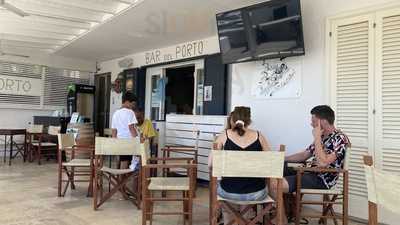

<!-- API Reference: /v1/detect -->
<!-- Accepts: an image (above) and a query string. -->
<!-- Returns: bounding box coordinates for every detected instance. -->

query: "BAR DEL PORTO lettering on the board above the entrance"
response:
[145,41,204,65]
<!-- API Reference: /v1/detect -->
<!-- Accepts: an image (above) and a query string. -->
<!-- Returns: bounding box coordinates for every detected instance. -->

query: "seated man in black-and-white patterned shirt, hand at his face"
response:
[271,105,350,224]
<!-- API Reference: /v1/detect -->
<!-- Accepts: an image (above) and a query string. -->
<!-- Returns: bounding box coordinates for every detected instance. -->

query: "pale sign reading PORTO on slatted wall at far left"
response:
[0,75,42,96]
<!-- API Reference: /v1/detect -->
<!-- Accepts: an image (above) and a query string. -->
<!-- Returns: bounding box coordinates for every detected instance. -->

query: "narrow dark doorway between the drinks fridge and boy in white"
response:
[94,73,111,136]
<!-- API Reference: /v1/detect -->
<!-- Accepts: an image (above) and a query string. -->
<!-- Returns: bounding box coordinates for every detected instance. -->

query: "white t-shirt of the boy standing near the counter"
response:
[111,108,137,138]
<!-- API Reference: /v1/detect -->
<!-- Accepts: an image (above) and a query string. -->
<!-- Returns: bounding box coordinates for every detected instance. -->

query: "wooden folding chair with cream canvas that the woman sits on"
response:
[210,145,285,225]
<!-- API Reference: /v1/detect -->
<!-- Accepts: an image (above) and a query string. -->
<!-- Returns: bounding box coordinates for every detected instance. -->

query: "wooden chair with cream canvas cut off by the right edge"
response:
[364,156,400,225]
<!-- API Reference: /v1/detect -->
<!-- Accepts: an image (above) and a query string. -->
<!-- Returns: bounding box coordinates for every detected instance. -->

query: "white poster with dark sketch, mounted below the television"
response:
[251,60,301,99]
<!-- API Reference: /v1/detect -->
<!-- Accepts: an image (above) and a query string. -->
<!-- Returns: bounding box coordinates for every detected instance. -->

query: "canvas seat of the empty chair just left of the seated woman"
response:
[149,177,190,191]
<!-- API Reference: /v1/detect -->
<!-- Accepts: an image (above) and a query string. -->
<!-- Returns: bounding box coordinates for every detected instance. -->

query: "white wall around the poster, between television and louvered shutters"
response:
[230,0,394,153]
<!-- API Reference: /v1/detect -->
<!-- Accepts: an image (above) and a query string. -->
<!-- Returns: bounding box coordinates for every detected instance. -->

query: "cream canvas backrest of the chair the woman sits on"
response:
[211,146,285,178]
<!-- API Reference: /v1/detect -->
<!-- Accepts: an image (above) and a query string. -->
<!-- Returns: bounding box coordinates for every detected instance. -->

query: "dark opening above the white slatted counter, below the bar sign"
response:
[165,65,195,115]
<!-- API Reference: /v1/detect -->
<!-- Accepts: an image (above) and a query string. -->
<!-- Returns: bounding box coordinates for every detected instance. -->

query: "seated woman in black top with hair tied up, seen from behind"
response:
[209,106,270,222]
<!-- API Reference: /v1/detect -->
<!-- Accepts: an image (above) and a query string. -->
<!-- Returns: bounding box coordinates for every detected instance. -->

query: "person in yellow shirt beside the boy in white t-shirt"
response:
[135,108,158,156]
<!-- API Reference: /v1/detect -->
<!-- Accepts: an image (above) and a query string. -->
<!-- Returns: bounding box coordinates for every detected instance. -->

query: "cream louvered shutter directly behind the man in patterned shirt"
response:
[329,15,374,220]
